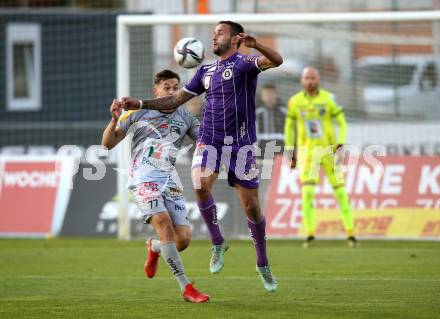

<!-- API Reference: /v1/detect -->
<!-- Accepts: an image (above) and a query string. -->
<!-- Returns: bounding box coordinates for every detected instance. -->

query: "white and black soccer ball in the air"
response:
[174,38,205,69]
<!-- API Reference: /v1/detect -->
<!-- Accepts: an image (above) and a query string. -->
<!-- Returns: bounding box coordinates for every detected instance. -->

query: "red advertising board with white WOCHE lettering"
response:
[0,158,71,236]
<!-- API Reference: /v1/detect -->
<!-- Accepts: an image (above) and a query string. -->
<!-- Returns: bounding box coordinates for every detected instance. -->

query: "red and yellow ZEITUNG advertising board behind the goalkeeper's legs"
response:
[265,156,440,237]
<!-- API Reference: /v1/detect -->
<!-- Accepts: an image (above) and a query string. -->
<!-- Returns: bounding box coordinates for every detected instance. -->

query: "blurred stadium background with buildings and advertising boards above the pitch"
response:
[0,0,440,239]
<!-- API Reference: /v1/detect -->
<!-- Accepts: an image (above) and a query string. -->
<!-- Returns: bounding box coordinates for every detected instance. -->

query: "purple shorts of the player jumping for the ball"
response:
[192,142,260,189]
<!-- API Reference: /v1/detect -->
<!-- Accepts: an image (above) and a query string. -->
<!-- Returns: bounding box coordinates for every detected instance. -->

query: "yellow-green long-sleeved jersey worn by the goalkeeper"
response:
[284,89,347,147]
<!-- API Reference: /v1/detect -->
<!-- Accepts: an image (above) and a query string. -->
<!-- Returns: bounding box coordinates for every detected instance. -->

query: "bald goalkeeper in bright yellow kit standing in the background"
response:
[284,67,357,247]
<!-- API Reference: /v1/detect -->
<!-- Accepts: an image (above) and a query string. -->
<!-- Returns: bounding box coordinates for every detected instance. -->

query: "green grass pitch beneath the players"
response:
[0,239,440,319]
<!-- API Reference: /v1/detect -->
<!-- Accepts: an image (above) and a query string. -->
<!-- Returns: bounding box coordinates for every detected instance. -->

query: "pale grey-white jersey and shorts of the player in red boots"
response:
[119,108,200,225]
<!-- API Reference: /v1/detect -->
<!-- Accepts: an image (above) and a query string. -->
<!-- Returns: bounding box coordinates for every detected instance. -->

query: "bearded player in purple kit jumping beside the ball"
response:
[121,21,283,292]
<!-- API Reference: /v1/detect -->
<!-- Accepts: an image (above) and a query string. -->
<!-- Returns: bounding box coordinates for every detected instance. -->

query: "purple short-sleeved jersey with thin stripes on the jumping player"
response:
[184,52,261,147]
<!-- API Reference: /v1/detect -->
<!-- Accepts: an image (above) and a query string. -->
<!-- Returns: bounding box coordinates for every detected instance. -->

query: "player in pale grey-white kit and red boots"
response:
[101,70,209,303]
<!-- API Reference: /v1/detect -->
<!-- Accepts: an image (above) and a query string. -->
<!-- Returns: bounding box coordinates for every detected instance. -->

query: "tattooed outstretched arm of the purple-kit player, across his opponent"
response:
[121,89,194,110]
